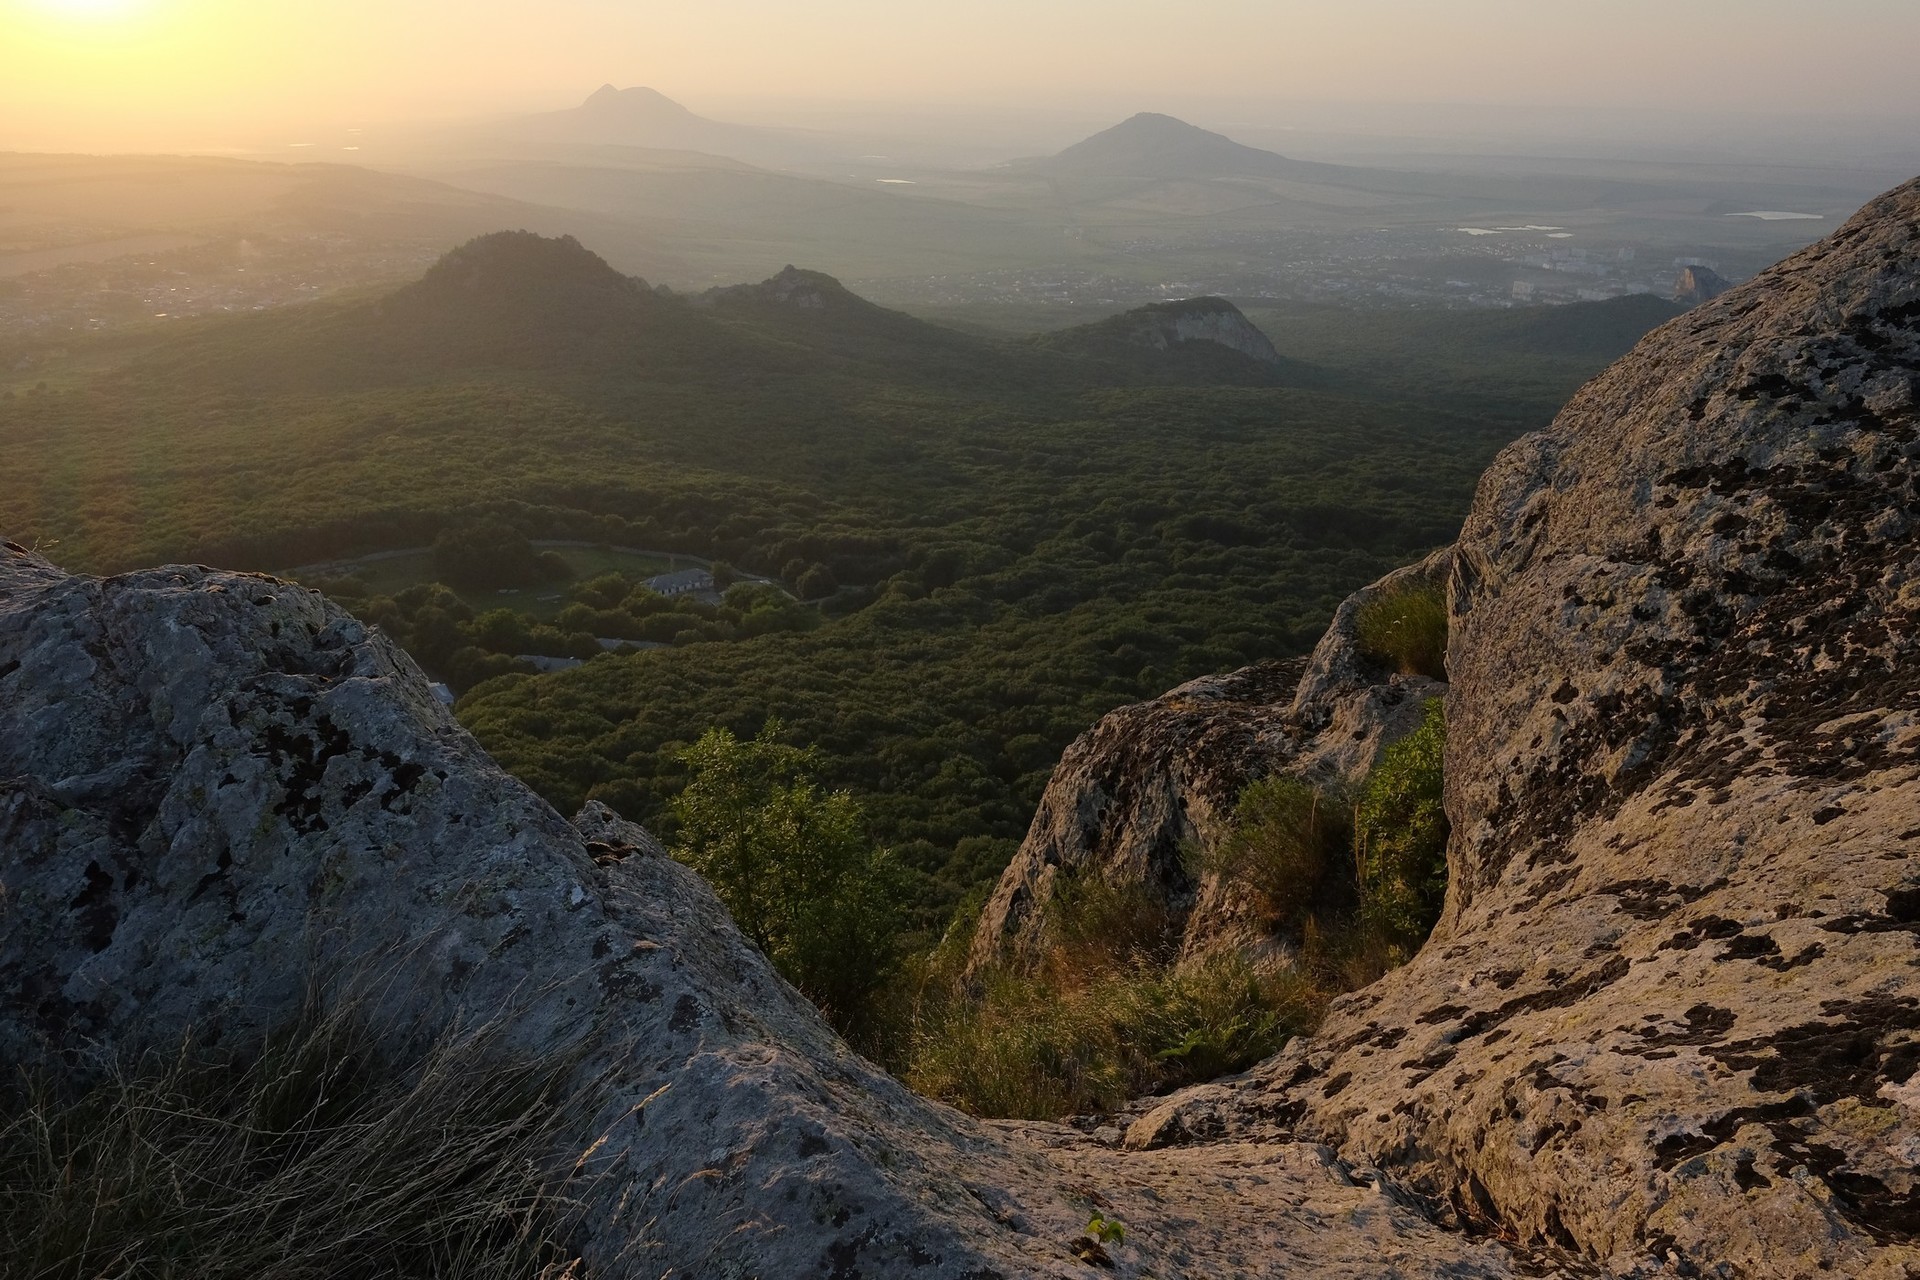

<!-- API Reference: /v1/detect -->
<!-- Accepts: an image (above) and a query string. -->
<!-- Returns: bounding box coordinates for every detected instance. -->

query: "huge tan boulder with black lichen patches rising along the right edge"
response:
[1129,182,1920,1276]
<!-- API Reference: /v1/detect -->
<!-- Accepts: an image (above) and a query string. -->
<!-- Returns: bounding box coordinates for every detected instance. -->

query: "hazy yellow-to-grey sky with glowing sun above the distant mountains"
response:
[0,0,1920,150]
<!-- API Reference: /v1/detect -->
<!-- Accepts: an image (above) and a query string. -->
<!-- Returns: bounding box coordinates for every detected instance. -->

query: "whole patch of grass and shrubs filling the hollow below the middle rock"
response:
[906,699,1448,1119]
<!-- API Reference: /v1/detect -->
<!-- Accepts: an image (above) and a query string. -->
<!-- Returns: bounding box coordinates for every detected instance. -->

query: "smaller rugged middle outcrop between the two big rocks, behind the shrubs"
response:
[968,551,1452,973]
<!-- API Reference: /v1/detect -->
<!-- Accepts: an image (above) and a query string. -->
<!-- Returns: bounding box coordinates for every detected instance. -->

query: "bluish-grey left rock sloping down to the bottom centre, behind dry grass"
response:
[0,545,1515,1280]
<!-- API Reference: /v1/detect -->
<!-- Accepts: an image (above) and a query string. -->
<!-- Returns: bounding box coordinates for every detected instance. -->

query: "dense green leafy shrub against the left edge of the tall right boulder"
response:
[1354,699,1450,954]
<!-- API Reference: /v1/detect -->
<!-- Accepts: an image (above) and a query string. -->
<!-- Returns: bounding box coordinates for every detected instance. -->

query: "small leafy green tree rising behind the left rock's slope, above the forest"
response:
[674,722,900,1044]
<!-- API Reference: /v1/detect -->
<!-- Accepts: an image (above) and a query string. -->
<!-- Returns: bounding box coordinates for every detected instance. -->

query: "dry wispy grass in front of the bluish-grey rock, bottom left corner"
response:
[0,1013,595,1280]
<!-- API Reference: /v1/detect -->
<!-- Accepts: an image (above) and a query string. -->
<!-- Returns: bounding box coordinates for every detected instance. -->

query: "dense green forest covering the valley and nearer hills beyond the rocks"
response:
[0,234,1670,938]
